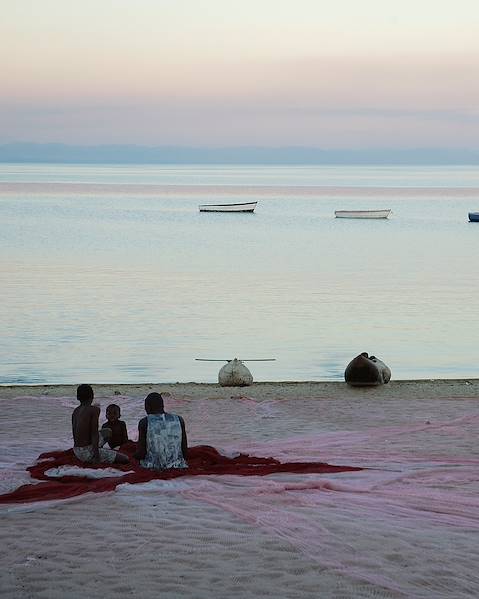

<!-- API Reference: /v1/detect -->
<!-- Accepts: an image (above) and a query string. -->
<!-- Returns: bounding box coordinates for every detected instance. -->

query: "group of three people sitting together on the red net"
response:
[72,384,188,470]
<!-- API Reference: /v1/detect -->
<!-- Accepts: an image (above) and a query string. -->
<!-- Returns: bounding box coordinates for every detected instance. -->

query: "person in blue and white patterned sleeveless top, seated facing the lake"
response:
[134,393,188,470]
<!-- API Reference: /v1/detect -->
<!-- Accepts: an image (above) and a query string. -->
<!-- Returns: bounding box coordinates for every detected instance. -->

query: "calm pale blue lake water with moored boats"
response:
[0,164,479,384]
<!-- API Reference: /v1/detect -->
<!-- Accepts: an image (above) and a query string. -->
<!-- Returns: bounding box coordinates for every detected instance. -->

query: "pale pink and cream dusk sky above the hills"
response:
[0,0,479,149]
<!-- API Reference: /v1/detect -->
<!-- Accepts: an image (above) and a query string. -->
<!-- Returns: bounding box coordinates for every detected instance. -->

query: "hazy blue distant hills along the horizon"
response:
[0,143,479,165]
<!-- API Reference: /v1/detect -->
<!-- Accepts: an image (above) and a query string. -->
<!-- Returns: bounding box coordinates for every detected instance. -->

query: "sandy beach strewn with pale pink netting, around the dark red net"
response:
[0,379,479,599]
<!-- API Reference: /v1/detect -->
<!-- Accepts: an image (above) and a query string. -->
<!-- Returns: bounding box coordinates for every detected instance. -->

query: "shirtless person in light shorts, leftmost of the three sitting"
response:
[72,385,129,464]
